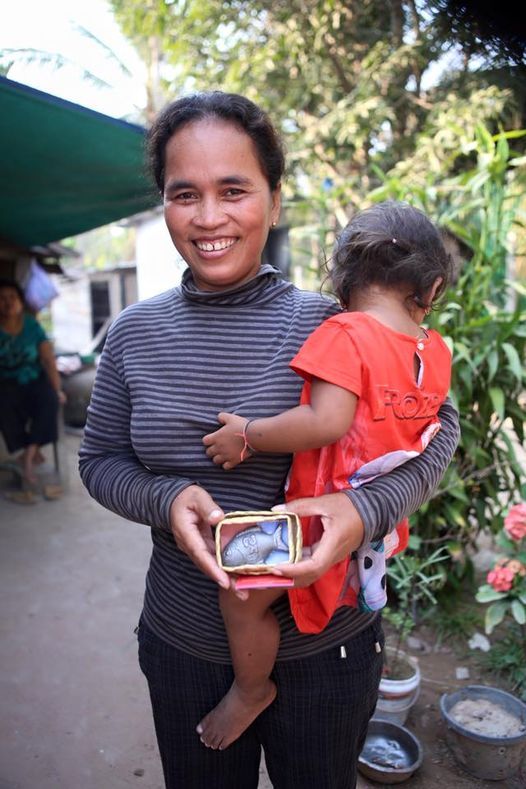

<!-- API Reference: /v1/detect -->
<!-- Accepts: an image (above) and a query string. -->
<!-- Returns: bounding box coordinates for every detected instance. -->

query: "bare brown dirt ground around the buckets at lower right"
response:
[358,626,526,789]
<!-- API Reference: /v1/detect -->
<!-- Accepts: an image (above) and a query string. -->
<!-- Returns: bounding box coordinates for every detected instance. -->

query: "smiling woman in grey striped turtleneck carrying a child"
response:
[80,92,458,789]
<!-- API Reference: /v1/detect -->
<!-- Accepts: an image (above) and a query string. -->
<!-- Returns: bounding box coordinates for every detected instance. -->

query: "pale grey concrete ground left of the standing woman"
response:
[0,435,271,789]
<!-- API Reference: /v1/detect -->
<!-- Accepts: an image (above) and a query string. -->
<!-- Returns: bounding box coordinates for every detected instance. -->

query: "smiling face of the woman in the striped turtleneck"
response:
[164,119,280,290]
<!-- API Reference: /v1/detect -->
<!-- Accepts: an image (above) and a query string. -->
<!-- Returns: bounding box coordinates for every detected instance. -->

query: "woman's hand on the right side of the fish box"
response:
[272,492,364,587]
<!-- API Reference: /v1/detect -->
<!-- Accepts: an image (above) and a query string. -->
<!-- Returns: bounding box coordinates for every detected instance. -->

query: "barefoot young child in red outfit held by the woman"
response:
[197,201,451,748]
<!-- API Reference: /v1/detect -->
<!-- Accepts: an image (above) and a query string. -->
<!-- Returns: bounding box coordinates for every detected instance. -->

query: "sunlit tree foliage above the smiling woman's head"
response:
[111,0,526,219]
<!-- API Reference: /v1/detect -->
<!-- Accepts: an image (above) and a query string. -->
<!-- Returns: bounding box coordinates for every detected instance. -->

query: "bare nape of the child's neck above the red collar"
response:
[347,285,425,337]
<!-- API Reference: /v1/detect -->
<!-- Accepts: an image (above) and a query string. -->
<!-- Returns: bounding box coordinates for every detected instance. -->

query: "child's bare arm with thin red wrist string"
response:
[203,378,358,469]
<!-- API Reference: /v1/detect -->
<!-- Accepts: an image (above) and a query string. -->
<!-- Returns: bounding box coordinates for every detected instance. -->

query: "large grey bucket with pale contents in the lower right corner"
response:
[440,685,526,781]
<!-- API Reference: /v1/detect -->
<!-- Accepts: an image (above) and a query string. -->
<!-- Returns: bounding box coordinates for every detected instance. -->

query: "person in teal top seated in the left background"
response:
[0,280,65,483]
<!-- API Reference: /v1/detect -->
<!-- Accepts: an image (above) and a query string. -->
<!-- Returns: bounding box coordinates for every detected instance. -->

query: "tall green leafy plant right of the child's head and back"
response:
[372,125,526,568]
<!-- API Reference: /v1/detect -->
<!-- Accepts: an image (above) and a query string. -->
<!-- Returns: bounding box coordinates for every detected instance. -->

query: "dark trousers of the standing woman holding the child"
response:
[139,622,383,789]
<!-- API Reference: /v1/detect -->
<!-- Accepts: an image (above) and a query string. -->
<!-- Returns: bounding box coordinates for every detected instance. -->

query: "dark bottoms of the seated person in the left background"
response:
[0,373,58,452]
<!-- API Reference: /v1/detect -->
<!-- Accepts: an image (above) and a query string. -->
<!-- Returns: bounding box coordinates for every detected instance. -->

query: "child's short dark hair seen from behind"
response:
[329,200,452,308]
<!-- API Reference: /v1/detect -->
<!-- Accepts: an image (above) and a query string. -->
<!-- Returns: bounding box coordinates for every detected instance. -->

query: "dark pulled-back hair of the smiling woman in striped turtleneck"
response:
[147,90,285,192]
